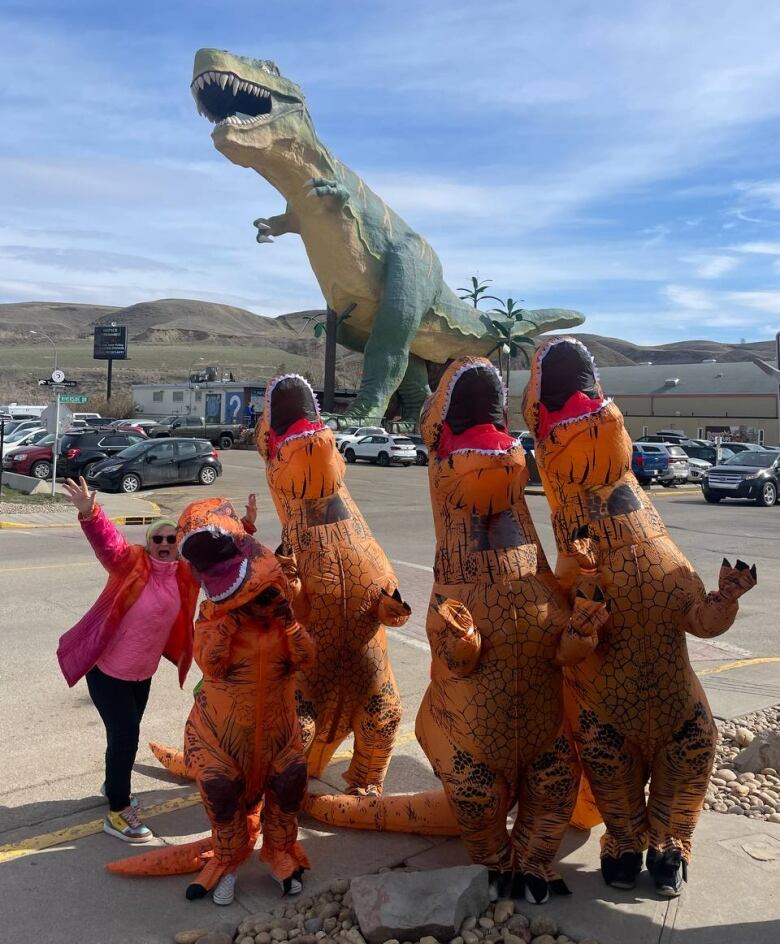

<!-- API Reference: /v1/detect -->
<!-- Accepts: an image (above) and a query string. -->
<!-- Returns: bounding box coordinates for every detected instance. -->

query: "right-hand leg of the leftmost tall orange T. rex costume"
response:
[344,662,401,795]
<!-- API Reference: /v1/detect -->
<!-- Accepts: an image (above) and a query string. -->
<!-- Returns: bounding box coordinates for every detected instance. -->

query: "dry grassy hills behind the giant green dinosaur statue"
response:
[0,298,774,402]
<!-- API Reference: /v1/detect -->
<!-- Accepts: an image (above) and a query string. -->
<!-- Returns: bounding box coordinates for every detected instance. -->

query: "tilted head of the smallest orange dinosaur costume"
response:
[178,498,284,610]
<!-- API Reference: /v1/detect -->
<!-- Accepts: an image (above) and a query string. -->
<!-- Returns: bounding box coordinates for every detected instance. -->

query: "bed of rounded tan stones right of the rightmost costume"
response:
[704,705,780,823]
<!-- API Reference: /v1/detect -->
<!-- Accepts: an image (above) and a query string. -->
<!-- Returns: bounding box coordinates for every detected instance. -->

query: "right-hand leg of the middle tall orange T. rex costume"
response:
[512,732,580,881]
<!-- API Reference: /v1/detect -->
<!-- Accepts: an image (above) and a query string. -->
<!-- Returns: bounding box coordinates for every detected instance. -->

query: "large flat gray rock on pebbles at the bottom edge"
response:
[350,865,490,944]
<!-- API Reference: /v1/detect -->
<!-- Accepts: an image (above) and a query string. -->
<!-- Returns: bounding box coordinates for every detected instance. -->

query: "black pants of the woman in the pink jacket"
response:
[87,666,152,812]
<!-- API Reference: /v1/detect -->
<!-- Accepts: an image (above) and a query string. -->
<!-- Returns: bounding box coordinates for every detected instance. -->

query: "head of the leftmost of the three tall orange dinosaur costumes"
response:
[257,374,345,498]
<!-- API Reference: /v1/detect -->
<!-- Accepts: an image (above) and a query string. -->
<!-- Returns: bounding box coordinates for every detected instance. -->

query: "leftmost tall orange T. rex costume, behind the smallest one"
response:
[257,375,411,796]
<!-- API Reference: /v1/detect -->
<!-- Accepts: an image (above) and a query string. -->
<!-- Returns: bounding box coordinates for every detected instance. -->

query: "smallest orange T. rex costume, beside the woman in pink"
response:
[108,498,314,903]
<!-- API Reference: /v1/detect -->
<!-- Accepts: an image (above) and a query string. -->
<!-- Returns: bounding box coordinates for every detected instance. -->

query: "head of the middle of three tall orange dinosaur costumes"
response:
[420,357,528,514]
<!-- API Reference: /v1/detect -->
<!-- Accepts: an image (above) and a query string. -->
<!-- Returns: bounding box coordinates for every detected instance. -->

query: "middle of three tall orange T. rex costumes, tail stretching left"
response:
[307,358,607,903]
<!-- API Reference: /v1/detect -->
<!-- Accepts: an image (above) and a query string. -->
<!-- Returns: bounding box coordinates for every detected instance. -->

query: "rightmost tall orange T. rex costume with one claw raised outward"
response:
[524,338,756,895]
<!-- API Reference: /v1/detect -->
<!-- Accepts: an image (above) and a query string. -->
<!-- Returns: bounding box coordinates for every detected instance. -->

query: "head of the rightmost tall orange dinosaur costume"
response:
[523,338,631,488]
